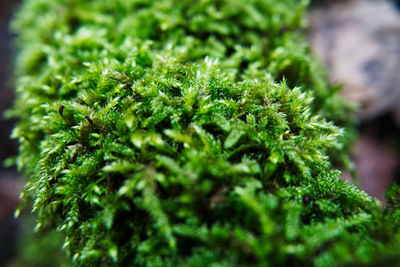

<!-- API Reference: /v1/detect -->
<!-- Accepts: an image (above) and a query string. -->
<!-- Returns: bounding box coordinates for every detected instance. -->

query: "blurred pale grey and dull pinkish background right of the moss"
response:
[308,0,400,202]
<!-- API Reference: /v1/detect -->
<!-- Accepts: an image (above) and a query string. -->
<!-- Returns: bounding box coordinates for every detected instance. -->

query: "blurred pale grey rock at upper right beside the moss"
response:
[309,0,400,122]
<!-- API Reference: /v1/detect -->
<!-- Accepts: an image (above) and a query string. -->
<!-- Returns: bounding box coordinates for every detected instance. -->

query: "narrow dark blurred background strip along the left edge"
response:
[0,0,21,266]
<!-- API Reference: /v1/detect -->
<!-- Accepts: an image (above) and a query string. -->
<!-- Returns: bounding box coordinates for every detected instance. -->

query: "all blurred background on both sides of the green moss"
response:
[0,0,400,266]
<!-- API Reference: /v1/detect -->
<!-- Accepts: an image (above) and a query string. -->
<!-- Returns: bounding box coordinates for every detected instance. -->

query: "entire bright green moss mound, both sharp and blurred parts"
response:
[10,0,400,266]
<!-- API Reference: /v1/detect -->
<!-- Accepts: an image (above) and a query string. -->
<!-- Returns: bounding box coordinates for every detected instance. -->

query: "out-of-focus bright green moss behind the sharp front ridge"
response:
[14,0,348,123]
